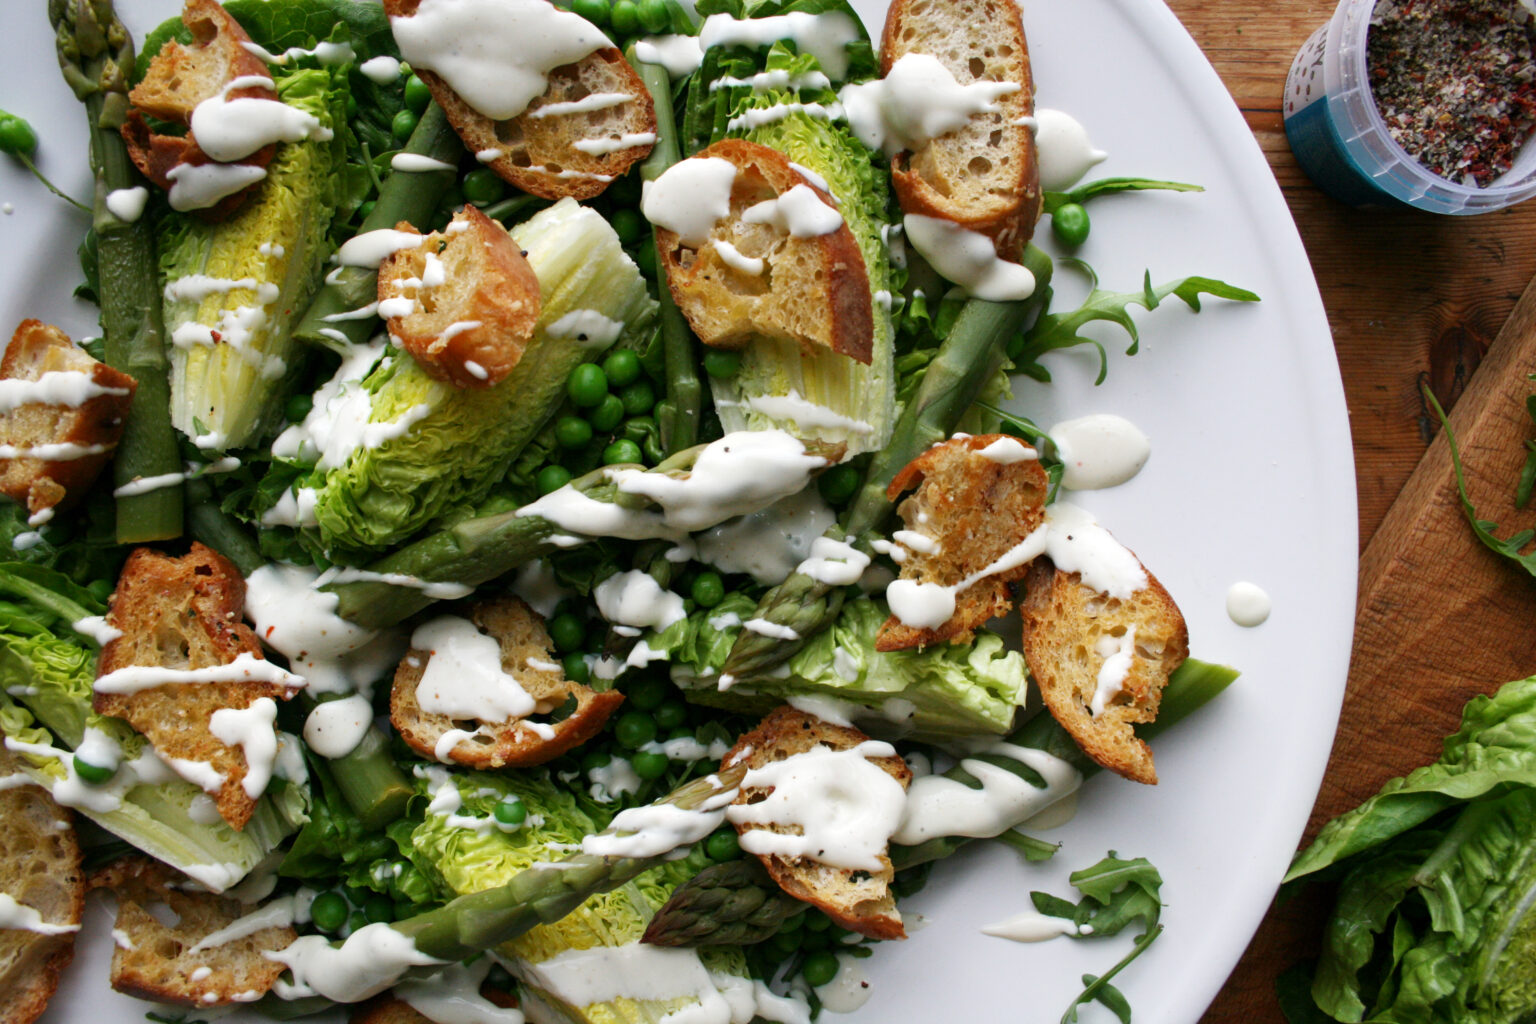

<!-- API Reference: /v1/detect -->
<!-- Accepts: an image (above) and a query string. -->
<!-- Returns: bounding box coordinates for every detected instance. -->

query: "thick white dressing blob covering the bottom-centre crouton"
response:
[725,740,906,870]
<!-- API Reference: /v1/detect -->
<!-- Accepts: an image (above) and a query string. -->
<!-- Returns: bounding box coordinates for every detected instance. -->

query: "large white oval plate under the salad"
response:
[9,0,1356,1024]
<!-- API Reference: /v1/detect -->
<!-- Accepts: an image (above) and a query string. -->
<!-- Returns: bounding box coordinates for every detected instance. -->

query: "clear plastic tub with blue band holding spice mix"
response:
[1284,0,1536,215]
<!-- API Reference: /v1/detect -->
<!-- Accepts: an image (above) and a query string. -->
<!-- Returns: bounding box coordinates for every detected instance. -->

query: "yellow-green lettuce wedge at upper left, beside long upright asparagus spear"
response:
[160,69,347,448]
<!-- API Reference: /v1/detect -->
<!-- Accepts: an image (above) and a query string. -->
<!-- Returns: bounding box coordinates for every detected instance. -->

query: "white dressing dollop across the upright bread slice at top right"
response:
[837,54,1020,157]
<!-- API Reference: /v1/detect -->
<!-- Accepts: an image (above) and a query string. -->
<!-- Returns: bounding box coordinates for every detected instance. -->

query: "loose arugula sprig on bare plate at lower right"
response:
[1029,851,1163,1024]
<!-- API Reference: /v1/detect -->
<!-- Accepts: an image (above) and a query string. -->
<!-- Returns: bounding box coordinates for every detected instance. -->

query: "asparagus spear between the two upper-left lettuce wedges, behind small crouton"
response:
[293,103,464,352]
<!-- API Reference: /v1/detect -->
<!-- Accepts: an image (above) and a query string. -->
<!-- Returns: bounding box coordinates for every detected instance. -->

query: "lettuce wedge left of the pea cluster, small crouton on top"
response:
[305,200,656,553]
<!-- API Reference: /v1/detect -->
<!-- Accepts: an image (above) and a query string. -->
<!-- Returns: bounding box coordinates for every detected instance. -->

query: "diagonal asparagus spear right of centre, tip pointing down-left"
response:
[722,246,1052,680]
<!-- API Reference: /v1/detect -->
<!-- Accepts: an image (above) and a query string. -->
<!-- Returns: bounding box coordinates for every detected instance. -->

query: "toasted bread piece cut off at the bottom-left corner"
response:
[0,746,86,1024]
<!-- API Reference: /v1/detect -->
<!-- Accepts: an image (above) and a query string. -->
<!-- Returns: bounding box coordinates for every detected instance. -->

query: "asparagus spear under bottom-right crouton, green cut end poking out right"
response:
[642,659,1236,946]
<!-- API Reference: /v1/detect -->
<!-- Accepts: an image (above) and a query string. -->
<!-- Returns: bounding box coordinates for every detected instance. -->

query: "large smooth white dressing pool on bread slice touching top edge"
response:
[390,0,613,121]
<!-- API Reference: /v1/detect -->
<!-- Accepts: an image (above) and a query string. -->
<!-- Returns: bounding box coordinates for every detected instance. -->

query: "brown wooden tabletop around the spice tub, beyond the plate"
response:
[1169,0,1536,1024]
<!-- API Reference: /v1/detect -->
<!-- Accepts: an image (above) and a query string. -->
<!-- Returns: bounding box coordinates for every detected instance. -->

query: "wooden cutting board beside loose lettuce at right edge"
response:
[1204,270,1536,1024]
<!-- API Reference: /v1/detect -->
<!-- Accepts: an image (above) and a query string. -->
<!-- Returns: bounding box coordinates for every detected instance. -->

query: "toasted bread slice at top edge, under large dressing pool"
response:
[384,0,656,200]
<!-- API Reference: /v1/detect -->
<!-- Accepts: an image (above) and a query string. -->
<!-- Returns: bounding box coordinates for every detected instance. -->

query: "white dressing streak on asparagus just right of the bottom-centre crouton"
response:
[892,742,1083,846]
